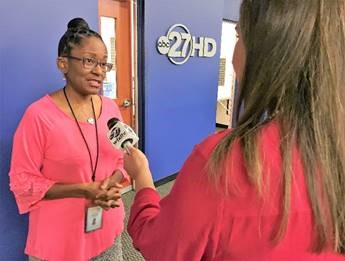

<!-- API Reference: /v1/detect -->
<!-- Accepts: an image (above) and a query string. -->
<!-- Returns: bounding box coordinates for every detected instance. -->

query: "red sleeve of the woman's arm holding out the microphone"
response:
[128,145,222,261]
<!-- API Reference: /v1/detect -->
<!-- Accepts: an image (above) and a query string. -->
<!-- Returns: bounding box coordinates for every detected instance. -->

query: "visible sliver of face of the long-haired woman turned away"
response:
[232,25,246,82]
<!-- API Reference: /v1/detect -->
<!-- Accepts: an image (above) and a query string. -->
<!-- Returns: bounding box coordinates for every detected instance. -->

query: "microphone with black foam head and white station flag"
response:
[107,118,139,153]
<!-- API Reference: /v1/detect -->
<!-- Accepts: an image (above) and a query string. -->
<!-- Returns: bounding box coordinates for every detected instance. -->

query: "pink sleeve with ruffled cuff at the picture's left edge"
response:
[9,108,55,214]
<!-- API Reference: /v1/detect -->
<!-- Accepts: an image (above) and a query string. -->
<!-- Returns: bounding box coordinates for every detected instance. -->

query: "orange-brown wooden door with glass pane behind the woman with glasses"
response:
[98,0,136,127]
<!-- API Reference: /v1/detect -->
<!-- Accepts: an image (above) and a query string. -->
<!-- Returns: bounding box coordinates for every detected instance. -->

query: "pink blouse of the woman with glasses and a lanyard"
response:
[9,95,127,261]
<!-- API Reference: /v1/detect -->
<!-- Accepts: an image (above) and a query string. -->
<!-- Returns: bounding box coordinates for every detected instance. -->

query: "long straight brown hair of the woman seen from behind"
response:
[209,0,345,253]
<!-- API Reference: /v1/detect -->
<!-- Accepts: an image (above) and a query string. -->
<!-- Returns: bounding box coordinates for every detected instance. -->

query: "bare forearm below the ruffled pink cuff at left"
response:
[44,183,87,199]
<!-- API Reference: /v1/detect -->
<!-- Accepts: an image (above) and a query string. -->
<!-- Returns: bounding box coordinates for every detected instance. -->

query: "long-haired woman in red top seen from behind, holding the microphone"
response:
[125,0,345,261]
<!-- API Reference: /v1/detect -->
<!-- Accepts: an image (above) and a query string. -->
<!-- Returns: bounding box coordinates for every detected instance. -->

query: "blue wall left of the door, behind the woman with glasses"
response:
[0,0,98,261]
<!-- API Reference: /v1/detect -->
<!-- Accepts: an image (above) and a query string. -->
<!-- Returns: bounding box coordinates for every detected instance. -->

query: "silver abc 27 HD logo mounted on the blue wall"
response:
[156,24,217,65]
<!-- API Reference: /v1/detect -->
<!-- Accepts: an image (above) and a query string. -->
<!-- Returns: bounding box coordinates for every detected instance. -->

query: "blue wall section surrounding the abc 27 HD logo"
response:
[144,0,224,180]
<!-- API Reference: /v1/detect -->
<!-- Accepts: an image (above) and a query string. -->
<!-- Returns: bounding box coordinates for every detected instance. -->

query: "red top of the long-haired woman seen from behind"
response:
[128,123,345,261]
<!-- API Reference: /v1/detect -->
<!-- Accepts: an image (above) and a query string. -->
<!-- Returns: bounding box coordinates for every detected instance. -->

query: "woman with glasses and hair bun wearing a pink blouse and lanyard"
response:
[9,18,127,261]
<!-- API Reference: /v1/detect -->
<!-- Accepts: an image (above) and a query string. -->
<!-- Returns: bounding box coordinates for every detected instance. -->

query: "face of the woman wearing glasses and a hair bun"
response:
[65,37,107,95]
